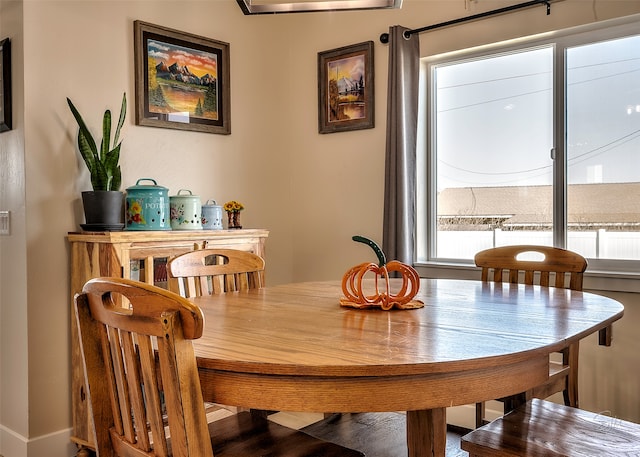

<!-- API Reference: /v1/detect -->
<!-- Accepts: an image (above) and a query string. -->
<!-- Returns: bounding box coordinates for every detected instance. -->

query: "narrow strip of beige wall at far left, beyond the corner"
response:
[0,2,28,448]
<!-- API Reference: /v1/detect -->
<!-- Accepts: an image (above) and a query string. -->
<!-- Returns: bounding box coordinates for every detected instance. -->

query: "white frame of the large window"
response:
[416,15,640,292]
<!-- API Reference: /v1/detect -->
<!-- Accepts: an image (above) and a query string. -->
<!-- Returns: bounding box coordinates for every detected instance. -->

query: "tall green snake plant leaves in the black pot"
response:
[67,93,127,191]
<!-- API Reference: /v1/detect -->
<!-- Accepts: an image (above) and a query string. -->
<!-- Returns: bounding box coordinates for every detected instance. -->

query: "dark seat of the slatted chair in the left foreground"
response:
[209,411,364,457]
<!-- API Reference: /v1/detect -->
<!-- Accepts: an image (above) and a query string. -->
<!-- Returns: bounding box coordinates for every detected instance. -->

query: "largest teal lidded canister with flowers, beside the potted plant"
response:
[125,178,171,230]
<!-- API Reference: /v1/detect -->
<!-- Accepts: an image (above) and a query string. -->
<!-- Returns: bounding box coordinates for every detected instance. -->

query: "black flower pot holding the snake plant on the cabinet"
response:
[82,190,124,230]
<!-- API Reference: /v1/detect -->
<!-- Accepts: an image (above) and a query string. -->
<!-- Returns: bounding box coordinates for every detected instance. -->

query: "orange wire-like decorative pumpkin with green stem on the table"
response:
[340,235,424,310]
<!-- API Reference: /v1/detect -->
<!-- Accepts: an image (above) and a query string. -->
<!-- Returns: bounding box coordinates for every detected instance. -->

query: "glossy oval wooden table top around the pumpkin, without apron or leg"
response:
[193,279,623,376]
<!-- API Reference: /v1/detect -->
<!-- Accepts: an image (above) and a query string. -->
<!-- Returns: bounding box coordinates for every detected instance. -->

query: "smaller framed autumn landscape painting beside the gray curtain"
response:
[318,41,374,133]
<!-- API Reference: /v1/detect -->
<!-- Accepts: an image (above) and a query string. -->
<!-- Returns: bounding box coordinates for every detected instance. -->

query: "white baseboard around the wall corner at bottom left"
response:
[0,426,78,457]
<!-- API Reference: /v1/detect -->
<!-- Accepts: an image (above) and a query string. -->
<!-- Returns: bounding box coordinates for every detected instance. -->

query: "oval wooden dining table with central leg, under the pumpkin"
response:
[192,279,624,457]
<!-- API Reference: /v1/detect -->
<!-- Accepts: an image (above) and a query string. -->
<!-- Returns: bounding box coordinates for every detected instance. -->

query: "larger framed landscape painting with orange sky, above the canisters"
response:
[134,21,231,135]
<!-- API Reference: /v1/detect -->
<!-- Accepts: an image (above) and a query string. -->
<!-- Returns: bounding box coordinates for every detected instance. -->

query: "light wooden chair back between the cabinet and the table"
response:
[167,249,264,298]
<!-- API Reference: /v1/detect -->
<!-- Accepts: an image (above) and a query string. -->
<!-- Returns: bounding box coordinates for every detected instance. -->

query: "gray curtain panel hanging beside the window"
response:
[382,26,420,265]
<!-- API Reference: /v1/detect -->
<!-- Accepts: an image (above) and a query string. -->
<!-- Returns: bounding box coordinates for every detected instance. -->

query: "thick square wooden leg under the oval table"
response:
[407,408,447,457]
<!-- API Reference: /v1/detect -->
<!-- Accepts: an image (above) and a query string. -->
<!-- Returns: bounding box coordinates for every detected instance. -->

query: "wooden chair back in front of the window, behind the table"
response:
[475,245,587,290]
